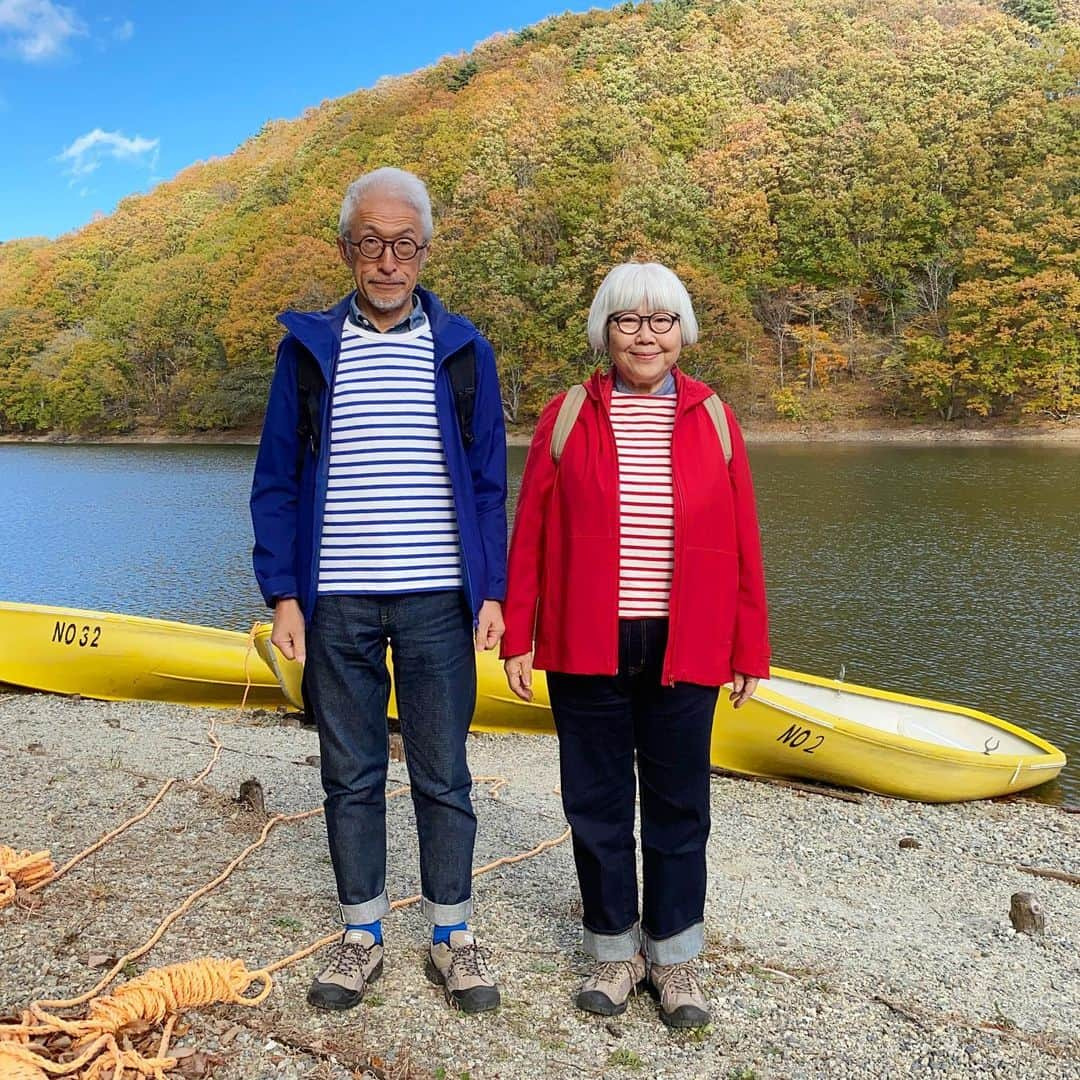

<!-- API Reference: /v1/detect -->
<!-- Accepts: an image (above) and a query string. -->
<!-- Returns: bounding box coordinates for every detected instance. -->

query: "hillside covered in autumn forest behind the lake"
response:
[0,0,1080,434]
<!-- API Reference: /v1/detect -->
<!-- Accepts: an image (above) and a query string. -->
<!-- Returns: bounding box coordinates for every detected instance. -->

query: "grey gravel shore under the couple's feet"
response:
[0,693,1080,1080]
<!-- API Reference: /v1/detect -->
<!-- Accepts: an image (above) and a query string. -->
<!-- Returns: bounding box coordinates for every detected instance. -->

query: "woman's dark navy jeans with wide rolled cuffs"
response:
[548,619,719,964]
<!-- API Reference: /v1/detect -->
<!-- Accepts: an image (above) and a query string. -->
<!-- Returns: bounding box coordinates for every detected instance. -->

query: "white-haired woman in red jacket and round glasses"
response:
[502,262,769,1027]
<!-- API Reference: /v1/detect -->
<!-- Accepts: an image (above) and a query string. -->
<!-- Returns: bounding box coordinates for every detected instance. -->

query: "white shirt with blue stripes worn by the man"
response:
[319,319,461,595]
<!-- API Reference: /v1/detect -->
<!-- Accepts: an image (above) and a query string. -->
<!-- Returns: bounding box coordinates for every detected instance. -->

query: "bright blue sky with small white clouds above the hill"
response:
[0,0,609,241]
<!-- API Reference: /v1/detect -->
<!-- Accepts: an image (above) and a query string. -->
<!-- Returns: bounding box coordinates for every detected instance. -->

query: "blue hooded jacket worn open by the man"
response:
[251,288,507,621]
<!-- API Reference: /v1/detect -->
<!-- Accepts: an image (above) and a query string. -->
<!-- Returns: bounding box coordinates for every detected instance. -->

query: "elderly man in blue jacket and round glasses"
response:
[252,168,507,1012]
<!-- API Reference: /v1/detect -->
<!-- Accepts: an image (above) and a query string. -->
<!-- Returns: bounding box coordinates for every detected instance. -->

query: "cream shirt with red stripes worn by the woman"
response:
[611,390,675,619]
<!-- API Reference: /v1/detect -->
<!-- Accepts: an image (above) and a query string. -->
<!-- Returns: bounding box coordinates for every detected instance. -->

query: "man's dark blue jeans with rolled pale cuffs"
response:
[303,591,476,926]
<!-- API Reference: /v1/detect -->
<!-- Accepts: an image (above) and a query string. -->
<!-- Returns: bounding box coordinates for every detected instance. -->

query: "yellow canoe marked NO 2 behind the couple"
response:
[255,624,1065,802]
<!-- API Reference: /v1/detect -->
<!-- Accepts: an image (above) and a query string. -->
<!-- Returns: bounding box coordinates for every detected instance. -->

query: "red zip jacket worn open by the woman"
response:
[502,368,769,686]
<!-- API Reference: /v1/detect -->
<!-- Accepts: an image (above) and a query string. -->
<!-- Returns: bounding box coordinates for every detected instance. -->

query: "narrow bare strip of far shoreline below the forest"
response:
[0,420,1080,446]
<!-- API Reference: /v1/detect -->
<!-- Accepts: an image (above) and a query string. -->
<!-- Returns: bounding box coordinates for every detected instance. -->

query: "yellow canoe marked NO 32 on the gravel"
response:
[0,603,287,707]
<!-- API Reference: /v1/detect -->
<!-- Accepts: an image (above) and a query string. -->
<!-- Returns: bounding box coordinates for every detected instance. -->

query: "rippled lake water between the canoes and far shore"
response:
[0,444,1080,801]
